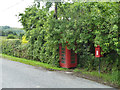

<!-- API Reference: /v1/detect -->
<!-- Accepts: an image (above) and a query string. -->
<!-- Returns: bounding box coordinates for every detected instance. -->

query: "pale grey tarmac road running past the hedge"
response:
[0,58,111,88]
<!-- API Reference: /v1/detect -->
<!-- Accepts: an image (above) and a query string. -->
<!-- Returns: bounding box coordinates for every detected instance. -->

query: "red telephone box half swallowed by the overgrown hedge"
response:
[59,44,77,68]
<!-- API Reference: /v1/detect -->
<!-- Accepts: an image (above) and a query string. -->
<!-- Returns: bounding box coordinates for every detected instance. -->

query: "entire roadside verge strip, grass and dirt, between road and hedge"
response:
[0,54,120,89]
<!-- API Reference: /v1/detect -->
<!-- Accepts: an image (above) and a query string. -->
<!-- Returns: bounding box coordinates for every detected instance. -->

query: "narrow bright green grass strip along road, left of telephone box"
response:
[0,54,68,71]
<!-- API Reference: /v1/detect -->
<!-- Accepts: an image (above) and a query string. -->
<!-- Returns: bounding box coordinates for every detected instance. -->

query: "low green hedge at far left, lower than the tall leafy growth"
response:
[0,39,29,59]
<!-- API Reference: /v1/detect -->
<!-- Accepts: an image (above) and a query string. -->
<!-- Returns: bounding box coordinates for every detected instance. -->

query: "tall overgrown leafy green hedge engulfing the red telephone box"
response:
[2,2,120,85]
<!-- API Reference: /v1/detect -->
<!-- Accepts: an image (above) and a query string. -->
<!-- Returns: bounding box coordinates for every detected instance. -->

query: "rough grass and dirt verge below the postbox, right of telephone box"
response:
[73,68,120,89]
